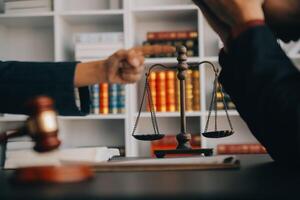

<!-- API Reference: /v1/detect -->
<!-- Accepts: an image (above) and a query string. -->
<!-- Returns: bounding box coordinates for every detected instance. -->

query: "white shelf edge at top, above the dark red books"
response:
[133,5,198,12]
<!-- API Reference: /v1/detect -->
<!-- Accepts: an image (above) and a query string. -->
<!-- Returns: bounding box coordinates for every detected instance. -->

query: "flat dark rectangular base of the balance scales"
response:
[154,148,213,158]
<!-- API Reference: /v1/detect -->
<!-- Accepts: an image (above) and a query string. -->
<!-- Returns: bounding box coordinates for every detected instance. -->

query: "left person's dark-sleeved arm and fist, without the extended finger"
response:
[0,49,144,115]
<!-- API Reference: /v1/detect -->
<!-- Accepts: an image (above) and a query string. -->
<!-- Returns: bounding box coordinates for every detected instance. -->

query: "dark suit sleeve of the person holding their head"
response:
[220,26,300,162]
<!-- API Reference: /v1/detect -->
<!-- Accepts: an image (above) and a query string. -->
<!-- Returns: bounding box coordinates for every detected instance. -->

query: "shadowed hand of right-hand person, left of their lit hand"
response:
[193,0,230,49]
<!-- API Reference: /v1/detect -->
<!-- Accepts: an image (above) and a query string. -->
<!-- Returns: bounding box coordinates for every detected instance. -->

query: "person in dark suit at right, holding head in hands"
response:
[194,0,300,163]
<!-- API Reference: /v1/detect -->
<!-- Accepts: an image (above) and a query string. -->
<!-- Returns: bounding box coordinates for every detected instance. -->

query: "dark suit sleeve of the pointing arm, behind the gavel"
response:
[0,61,89,115]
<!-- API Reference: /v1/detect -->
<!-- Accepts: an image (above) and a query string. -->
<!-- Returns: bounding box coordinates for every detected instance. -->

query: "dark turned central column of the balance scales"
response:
[176,46,191,149]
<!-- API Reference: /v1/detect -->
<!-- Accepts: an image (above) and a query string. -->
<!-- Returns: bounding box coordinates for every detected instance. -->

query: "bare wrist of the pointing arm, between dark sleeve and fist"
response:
[74,61,107,87]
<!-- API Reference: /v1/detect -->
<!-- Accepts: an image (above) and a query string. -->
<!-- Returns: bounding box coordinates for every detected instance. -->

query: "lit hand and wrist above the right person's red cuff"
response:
[199,0,264,28]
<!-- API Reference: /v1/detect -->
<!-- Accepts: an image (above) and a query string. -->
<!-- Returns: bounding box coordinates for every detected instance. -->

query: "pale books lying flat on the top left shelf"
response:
[4,0,52,14]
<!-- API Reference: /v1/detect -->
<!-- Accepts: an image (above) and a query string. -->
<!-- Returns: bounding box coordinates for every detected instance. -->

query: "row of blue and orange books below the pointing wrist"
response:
[90,83,125,114]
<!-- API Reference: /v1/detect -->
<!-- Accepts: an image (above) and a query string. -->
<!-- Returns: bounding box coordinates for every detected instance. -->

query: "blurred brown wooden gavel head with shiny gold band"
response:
[26,96,61,152]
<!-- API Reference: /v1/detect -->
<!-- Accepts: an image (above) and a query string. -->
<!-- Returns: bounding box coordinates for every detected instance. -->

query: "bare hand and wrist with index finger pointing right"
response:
[74,45,175,87]
